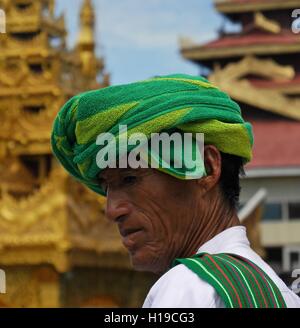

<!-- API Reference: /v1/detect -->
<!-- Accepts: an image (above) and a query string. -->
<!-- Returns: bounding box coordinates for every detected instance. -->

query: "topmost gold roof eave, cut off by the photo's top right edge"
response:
[215,0,299,14]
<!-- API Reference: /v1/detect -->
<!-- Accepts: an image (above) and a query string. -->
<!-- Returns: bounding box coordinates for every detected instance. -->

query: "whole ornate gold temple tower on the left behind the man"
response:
[0,0,115,272]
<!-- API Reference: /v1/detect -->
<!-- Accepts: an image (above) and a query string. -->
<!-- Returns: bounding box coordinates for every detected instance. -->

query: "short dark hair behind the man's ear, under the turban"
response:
[220,152,245,208]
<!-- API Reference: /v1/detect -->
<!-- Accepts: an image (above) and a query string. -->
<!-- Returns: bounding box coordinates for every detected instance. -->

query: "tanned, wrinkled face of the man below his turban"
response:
[100,169,199,273]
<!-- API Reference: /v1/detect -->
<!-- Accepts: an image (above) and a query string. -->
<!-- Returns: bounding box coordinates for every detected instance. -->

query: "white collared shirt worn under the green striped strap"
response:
[143,226,300,308]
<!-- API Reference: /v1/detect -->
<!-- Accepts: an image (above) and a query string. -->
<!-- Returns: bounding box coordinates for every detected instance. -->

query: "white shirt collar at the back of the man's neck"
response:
[197,226,250,254]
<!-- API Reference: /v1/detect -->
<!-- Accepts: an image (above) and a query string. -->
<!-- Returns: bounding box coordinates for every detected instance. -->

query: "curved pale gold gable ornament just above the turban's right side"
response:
[209,56,300,121]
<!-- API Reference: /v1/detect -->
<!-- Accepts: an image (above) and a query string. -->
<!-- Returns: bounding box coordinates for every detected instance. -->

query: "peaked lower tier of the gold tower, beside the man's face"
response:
[0,168,124,271]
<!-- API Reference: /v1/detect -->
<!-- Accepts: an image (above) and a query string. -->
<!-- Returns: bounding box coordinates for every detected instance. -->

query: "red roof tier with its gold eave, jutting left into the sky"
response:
[181,30,300,62]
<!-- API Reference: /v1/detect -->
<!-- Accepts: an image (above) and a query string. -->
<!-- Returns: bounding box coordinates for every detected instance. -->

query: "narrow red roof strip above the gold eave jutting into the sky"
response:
[202,31,300,48]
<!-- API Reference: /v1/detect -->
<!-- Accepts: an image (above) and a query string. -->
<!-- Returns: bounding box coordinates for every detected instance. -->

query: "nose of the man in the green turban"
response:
[105,191,131,222]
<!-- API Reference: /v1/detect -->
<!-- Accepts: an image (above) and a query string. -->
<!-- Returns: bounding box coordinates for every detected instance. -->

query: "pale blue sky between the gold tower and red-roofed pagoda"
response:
[56,0,231,84]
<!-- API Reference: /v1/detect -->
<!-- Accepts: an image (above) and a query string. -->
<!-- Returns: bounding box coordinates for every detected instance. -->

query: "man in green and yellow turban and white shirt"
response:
[51,74,300,308]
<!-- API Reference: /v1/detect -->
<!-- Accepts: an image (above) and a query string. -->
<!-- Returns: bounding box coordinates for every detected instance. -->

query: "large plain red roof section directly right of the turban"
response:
[247,120,300,169]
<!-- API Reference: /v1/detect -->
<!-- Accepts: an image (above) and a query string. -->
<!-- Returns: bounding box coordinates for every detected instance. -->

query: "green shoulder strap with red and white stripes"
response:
[172,253,286,308]
